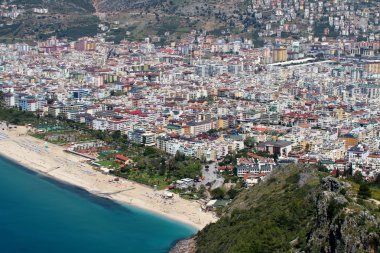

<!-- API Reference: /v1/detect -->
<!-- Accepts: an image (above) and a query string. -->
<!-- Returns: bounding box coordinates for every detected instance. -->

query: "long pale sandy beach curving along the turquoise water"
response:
[0,127,216,230]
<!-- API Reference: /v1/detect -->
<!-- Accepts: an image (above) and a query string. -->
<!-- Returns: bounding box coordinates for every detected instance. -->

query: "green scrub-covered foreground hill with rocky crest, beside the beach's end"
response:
[190,166,380,253]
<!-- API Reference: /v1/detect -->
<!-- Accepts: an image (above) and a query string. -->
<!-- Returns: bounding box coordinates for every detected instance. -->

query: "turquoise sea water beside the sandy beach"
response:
[0,157,196,253]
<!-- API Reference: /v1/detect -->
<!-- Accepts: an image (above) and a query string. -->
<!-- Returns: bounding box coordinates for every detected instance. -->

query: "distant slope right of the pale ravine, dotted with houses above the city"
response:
[93,0,380,44]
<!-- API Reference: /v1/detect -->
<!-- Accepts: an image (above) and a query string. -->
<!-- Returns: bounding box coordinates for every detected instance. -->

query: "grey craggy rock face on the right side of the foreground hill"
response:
[305,177,379,253]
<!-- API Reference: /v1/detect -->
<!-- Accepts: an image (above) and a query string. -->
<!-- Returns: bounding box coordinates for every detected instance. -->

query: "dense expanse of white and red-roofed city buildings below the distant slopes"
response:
[0,15,380,184]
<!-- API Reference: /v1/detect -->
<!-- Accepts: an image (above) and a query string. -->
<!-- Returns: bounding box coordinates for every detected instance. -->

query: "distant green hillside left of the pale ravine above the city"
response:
[0,0,99,43]
